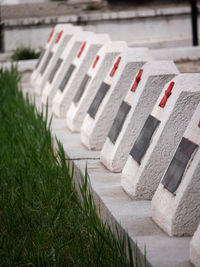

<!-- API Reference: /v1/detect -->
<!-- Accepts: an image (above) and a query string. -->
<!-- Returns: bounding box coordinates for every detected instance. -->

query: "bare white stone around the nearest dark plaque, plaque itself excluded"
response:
[152,104,200,236]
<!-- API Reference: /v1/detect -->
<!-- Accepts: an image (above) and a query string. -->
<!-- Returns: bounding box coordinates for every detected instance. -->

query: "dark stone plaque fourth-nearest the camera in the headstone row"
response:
[88,82,110,119]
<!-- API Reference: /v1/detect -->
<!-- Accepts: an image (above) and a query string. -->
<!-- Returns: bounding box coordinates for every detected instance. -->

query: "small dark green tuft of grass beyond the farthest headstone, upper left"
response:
[11,47,40,61]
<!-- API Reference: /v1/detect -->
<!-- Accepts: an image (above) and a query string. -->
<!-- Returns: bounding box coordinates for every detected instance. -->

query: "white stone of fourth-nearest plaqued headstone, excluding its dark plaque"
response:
[81,48,152,150]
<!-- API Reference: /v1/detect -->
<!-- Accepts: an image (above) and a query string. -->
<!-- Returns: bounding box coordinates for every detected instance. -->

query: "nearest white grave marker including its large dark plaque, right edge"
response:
[152,104,200,236]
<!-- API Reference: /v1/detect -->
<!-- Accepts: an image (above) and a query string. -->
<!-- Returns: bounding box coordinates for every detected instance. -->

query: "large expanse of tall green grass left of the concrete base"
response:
[0,68,145,267]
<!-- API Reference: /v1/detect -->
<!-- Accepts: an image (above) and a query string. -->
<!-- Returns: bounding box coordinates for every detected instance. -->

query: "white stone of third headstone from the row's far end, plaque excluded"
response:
[42,31,93,106]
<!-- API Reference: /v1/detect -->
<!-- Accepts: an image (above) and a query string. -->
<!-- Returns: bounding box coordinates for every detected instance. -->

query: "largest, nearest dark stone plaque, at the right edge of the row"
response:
[161,137,198,193]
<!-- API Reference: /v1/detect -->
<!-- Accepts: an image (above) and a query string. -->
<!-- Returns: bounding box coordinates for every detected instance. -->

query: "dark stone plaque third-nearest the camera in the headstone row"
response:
[108,101,131,144]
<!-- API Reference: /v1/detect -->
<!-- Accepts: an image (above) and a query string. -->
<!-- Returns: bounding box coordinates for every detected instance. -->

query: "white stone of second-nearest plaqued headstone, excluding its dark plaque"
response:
[121,74,200,199]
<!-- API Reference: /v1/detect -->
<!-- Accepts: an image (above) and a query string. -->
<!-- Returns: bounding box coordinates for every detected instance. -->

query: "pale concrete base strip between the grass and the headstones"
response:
[21,78,191,267]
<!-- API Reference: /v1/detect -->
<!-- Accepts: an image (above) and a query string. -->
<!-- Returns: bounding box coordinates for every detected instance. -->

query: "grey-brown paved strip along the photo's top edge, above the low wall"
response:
[1,0,191,20]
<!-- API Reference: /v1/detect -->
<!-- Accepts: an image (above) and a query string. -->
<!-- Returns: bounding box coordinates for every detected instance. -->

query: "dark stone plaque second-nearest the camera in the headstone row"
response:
[130,115,160,164]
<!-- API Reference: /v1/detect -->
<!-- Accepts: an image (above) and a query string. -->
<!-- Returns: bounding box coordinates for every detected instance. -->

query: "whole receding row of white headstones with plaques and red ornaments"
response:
[31,24,200,266]
